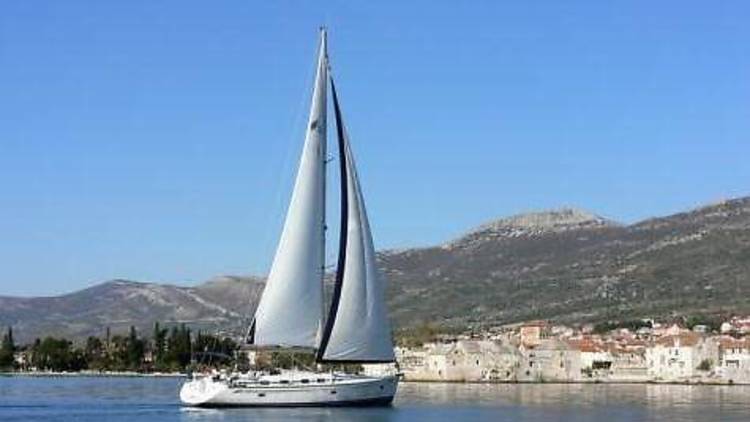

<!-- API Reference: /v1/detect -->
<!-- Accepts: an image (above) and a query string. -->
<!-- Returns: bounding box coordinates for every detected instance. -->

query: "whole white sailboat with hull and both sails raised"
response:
[180,28,398,406]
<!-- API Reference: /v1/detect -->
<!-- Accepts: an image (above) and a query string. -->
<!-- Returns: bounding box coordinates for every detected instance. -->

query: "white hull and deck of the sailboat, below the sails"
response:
[180,372,398,407]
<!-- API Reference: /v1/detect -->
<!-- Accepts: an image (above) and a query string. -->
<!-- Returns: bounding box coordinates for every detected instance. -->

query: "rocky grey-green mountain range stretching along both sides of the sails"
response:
[0,198,750,341]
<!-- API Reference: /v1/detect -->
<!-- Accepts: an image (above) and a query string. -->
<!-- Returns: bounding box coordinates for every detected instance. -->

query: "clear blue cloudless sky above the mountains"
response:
[0,0,750,296]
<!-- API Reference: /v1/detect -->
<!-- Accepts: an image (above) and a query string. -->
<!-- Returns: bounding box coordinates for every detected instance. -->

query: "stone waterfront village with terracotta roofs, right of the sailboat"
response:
[396,317,750,384]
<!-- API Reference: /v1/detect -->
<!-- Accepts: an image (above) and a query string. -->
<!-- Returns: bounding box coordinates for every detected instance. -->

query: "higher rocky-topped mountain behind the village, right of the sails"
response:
[382,198,750,326]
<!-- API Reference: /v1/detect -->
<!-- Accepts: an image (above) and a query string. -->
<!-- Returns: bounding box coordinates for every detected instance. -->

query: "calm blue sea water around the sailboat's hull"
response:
[0,376,750,422]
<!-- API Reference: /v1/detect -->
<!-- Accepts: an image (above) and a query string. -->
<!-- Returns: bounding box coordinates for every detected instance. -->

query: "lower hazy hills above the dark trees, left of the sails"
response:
[0,277,263,342]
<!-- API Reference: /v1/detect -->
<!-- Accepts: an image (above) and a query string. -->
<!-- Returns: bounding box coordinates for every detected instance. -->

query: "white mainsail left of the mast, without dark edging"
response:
[249,31,328,348]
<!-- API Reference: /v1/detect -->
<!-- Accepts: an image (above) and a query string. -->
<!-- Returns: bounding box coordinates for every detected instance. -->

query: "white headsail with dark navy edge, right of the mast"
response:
[317,79,394,362]
